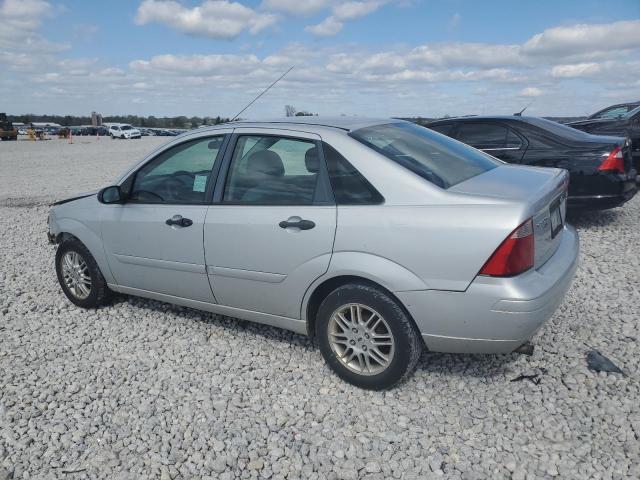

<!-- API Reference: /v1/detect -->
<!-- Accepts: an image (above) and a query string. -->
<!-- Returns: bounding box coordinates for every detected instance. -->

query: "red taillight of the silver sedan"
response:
[479,219,535,277]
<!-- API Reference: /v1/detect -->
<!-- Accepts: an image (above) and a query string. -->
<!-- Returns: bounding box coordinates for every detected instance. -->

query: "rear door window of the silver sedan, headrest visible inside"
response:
[223,135,320,205]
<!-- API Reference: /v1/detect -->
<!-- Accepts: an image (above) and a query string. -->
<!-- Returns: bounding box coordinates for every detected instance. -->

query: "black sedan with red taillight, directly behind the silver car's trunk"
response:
[426,115,638,209]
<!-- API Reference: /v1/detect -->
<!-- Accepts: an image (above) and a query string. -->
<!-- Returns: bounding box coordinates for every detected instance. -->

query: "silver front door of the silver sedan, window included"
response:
[102,130,231,302]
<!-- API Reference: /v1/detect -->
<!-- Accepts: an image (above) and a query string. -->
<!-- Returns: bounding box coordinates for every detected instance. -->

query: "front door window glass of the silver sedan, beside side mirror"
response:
[129,136,224,204]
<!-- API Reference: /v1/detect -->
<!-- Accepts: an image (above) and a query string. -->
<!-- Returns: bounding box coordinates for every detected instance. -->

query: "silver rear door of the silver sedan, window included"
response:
[204,128,337,319]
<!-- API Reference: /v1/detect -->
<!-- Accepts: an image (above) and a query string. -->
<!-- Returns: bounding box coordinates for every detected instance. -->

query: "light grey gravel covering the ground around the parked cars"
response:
[0,138,640,480]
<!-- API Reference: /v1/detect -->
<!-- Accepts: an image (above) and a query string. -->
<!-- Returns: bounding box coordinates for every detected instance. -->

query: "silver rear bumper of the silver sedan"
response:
[395,226,579,353]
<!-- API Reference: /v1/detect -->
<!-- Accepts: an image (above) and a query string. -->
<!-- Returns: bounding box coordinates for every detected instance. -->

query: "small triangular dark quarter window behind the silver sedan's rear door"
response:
[322,142,384,205]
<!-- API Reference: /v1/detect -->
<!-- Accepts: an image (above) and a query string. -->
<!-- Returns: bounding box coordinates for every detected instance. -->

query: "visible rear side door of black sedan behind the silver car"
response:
[456,122,527,163]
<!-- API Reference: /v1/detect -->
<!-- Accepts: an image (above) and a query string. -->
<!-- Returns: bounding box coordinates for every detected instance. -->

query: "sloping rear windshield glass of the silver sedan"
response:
[350,122,503,188]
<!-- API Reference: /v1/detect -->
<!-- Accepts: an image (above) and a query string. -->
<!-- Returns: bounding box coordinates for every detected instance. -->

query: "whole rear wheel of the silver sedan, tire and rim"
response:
[316,284,422,390]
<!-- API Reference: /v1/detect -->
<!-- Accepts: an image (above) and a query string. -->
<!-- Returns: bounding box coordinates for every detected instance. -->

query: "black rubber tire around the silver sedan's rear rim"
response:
[316,283,423,390]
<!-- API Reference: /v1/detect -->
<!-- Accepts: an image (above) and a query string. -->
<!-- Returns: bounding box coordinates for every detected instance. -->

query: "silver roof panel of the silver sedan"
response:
[194,116,404,132]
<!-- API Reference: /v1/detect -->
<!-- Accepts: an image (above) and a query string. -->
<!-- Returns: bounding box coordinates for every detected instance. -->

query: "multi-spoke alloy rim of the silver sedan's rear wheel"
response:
[328,303,395,375]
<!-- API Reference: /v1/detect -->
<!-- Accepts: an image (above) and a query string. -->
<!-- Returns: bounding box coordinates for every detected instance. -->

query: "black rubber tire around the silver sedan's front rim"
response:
[56,238,110,308]
